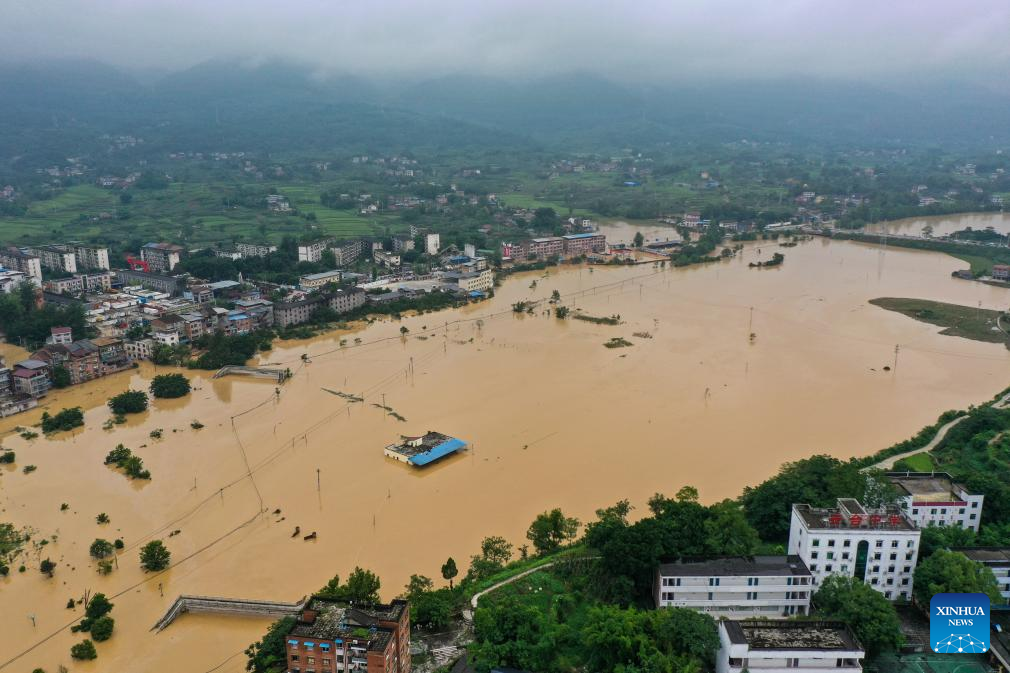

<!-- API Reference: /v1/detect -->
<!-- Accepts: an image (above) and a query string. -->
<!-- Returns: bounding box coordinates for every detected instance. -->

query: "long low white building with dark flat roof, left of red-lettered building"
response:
[653,556,813,618]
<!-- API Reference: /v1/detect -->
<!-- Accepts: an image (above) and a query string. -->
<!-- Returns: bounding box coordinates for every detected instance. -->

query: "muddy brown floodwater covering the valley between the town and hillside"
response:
[0,232,1010,673]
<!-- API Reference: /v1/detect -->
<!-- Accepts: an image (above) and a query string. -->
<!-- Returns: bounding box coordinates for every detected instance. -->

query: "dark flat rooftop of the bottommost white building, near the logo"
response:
[722,620,863,651]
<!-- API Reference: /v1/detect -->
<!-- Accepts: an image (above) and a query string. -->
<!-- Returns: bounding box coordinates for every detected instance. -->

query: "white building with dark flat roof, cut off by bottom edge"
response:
[715,619,867,673]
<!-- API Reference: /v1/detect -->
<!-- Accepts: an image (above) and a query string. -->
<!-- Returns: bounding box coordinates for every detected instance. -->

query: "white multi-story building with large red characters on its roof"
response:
[789,498,920,600]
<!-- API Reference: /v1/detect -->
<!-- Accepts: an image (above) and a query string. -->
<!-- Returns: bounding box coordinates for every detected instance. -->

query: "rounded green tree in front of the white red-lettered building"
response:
[813,575,904,657]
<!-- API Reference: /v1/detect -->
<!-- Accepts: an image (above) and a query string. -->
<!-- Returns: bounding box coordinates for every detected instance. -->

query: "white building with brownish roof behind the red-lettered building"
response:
[887,472,986,533]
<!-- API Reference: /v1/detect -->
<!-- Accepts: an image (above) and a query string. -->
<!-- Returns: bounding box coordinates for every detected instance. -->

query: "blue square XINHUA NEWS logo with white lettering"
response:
[929,593,989,654]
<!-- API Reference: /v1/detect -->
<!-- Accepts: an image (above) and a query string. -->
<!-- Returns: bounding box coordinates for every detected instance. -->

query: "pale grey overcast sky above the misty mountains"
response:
[0,0,1010,81]
